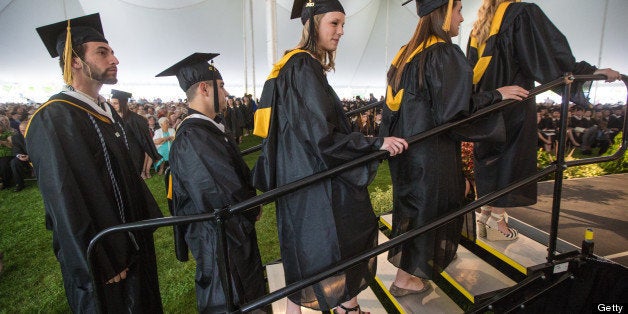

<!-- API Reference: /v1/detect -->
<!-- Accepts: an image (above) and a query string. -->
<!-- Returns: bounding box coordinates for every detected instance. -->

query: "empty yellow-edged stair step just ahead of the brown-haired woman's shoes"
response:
[381,215,525,302]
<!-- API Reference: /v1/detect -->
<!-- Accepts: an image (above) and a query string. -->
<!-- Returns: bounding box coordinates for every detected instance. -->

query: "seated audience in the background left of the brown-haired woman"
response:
[0,93,392,192]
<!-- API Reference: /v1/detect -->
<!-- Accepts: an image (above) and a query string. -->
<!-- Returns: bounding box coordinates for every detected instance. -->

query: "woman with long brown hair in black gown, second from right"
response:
[380,0,528,296]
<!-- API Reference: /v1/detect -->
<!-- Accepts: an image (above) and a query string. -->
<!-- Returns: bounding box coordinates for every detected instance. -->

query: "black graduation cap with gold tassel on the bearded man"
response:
[37,13,108,85]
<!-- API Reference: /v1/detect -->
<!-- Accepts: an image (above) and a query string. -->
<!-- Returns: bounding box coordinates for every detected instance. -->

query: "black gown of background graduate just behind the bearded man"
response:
[123,111,161,173]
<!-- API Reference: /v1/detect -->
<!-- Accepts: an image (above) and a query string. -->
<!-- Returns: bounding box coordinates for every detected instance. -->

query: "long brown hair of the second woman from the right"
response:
[387,0,452,92]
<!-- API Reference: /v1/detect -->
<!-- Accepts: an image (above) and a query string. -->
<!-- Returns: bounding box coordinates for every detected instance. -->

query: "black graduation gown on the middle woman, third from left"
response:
[254,52,383,310]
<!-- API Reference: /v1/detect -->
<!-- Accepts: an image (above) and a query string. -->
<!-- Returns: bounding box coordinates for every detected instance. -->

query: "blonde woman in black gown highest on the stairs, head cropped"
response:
[467,0,620,240]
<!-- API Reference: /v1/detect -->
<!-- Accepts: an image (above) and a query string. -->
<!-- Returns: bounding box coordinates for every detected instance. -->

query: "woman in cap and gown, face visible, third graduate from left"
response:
[254,0,407,313]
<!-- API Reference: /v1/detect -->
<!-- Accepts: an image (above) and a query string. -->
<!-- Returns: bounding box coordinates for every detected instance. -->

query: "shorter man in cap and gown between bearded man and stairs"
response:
[158,53,266,313]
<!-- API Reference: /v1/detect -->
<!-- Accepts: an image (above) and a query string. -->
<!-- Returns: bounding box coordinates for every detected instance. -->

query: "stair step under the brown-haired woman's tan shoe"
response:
[377,232,463,314]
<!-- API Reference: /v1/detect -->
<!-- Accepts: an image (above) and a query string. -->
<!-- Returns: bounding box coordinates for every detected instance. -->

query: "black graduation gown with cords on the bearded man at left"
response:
[26,93,162,313]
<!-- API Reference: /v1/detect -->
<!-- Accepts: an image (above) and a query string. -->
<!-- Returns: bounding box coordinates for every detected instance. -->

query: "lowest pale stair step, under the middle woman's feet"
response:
[266,263,386,314]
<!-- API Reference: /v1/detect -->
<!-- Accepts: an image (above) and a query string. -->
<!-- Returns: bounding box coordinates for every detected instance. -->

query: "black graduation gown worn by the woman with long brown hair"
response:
[380,42,502,278]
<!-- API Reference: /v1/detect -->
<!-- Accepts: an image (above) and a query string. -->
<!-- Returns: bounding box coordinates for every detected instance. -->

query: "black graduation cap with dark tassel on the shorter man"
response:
[156,52,222,122]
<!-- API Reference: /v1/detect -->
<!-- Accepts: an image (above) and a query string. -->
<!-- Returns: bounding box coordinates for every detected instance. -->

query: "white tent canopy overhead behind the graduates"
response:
[0,0,628,102]
